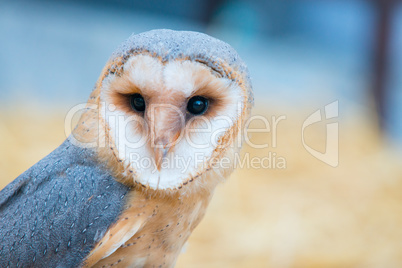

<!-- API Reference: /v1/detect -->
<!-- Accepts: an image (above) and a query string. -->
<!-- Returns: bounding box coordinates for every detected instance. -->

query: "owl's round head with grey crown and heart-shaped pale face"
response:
[72,30,253,190]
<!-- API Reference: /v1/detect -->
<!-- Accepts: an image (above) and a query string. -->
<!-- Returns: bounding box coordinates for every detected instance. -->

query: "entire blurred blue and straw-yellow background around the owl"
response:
[0,0,402,267]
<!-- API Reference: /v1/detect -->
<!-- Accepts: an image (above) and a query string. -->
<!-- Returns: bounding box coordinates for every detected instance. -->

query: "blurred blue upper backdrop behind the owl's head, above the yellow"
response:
[0,0,402,144]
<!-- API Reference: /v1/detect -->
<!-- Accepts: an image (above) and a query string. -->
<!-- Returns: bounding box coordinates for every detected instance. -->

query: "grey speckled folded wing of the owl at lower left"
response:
[0,140,130,267]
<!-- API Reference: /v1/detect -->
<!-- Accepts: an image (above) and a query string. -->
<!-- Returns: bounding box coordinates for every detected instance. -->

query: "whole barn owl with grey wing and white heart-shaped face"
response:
[0,30,253,267]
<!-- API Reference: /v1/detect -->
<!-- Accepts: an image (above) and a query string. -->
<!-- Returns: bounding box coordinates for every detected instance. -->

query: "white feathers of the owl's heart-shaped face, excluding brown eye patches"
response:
[100,55,244,189]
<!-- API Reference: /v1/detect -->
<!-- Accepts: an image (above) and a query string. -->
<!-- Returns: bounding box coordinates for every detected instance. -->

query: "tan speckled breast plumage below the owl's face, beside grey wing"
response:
[86,182,212,267]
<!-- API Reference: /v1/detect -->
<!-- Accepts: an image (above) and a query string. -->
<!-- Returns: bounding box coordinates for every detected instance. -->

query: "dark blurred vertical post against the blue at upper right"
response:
[372,0,395,130]
